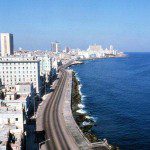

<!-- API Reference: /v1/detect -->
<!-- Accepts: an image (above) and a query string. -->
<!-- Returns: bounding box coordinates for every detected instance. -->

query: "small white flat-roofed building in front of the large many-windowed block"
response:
[0,83,35,114]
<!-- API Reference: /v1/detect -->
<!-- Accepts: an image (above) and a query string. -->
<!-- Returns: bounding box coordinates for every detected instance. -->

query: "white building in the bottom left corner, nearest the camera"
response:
[0,103,25,150]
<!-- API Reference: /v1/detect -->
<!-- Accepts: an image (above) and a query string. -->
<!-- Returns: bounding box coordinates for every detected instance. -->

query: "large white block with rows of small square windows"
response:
[0,59,41,93]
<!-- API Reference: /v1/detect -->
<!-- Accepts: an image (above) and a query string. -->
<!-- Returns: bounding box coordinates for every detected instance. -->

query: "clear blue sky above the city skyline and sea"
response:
[0,0,150,52]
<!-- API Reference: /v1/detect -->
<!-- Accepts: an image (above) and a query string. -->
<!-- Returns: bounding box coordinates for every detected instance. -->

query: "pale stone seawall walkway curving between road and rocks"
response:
[63,70,112,150]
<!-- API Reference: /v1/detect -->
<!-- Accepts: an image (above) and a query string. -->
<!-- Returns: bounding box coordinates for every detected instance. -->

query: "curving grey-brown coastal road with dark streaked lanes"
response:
[43,68,78,150]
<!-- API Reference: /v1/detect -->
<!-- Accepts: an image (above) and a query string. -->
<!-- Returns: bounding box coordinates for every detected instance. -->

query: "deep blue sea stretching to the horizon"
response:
[72,53,150,150]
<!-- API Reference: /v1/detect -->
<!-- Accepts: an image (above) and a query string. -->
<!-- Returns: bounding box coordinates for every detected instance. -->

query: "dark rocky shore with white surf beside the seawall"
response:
[71,72,119,150]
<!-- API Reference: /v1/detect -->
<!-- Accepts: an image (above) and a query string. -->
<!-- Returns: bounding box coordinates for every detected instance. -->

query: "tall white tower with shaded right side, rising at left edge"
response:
[1,33,14,57]
